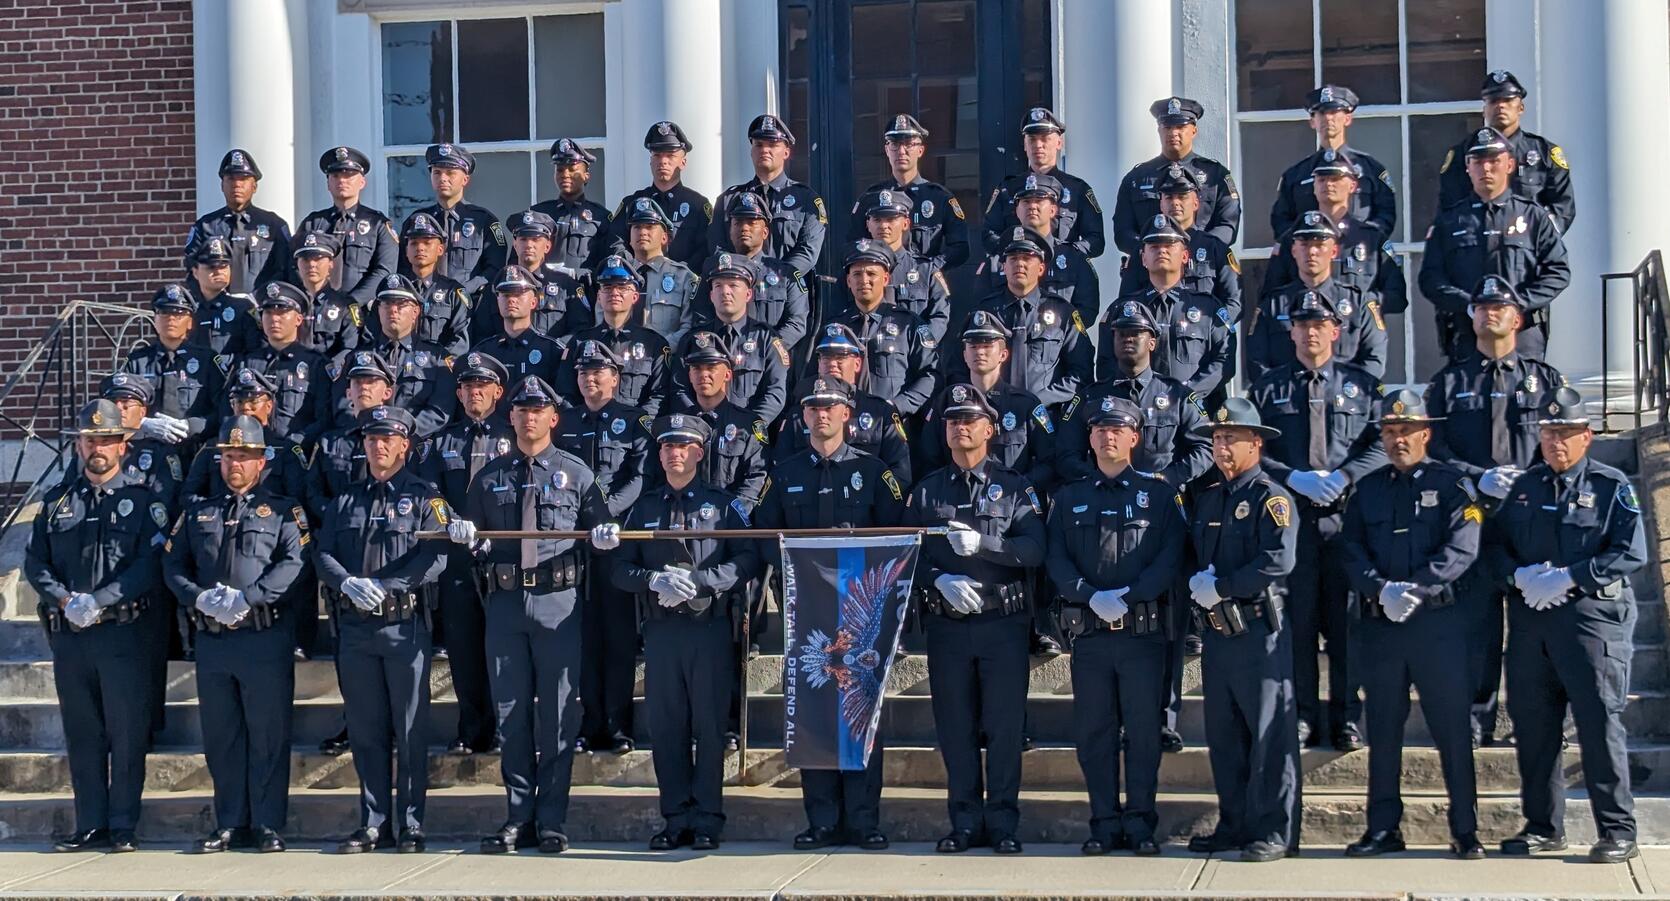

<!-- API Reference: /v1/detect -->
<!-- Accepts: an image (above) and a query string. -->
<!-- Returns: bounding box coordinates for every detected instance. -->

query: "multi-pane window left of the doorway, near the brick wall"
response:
[381,12,605,222]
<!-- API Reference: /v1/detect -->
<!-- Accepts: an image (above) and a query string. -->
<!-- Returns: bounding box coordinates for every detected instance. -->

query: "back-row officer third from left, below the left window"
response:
[401,143,506,298]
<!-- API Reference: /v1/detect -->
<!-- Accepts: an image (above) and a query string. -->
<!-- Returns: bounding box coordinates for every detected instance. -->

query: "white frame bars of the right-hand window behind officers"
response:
[1229,0,1490,389]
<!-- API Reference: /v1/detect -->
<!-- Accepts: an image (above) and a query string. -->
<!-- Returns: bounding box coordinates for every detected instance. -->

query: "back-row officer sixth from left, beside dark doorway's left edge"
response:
[708,113,830,275]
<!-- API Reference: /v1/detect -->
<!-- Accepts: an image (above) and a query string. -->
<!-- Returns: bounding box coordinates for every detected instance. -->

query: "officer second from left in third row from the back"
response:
[237,282,334,447]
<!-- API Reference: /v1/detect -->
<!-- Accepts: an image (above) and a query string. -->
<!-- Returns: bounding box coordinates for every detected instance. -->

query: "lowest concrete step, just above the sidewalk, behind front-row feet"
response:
[0,786,1596,854]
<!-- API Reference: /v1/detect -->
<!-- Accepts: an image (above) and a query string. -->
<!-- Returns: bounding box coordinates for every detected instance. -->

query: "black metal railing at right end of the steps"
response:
[1600,250,1670,432]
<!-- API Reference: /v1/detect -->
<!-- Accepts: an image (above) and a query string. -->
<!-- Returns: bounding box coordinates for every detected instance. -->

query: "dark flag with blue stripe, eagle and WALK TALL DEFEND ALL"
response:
[778,534,922,769]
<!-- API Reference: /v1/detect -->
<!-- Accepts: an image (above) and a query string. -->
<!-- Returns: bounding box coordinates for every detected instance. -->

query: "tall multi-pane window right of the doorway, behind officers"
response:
[1234,0,1486,384]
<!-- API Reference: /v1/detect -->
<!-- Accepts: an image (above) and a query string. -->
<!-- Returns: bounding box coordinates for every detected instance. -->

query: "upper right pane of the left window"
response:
[533,13,608,140]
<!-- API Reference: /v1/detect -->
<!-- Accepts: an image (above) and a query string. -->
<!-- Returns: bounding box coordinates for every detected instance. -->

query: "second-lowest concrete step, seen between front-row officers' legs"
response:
[0,746,1576,793]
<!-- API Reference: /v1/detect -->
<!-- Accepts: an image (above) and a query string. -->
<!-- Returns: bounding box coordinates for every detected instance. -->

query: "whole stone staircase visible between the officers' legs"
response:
[0,430,1670,846]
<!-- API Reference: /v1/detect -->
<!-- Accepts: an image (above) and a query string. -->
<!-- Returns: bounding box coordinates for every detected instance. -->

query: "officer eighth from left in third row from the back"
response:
[945,225,1094,407]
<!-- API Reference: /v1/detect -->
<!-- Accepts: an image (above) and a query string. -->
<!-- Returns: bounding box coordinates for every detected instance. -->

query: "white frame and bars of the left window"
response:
[369,2,611,215]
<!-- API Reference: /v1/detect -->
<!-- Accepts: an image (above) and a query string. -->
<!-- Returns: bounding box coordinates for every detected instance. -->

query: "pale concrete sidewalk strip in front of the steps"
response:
[0,843,1670,899]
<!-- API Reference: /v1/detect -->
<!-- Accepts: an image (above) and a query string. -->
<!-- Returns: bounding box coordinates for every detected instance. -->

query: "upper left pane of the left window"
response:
[382,22,453,143]
